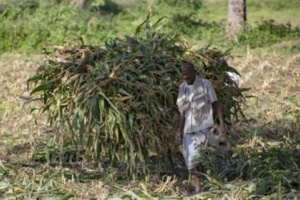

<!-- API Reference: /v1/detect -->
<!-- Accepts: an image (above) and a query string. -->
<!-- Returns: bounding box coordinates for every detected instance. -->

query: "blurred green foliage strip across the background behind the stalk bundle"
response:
[0,0,300,53]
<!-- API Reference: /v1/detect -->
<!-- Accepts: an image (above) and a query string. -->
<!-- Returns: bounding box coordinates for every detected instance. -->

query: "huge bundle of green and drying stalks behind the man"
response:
[28,20,245,174]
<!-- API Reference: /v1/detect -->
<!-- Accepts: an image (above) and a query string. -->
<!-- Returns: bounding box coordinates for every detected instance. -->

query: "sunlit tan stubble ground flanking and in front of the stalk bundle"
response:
[0,50,300,199]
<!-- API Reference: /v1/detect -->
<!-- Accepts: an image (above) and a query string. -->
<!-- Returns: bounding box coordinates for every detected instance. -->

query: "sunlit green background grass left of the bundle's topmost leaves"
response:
[0,1,139,52]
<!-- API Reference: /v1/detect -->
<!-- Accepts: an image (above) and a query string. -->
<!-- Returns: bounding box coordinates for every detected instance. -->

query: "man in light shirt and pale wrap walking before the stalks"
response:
[176,62,225,193]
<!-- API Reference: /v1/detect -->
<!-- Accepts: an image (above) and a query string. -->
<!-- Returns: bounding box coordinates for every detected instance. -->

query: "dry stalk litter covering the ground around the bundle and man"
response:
[0,48,300,199]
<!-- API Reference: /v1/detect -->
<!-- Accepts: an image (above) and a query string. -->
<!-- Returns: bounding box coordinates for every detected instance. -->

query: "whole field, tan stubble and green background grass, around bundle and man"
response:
[0,0,300,199]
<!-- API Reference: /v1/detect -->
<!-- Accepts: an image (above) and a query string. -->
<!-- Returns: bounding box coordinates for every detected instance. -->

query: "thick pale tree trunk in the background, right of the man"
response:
[226,0,247,39]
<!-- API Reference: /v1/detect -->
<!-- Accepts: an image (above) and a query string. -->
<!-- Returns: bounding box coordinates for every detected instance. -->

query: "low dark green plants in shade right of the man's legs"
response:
[201,135,300,199]
